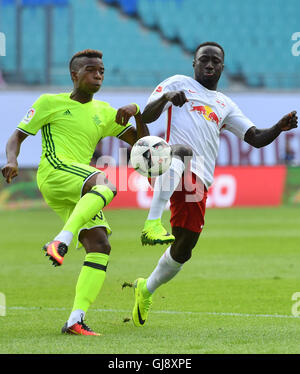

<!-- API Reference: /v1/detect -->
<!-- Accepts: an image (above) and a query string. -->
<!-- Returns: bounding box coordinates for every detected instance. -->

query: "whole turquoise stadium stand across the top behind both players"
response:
[0,0,300,89]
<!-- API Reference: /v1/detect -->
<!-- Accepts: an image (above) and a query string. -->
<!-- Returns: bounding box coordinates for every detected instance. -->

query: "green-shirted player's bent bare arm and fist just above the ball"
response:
[116,104,149,145]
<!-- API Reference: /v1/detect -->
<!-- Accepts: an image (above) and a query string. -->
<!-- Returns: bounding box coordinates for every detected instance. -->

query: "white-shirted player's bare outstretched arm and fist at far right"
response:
[244,110,298,148]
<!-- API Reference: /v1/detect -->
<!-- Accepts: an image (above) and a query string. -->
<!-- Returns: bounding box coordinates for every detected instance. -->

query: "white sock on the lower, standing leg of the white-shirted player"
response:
[147,247,183,293]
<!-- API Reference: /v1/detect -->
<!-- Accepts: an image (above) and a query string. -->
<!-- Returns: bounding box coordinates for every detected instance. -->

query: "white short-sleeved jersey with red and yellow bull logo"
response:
[147,75,254,188]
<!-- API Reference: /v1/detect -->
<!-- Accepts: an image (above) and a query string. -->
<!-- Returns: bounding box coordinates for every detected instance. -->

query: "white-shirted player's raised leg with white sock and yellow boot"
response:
[141,144,192,245]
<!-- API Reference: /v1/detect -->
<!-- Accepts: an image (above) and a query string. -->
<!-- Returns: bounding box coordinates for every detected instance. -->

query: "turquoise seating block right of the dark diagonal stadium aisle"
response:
[104,0,300,89]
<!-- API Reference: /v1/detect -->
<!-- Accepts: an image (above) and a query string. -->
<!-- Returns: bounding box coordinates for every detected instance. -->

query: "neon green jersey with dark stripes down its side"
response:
[18,93,132,185]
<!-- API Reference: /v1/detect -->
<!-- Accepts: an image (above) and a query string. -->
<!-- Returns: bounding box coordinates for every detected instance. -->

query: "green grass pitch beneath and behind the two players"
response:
[0,207,300,354]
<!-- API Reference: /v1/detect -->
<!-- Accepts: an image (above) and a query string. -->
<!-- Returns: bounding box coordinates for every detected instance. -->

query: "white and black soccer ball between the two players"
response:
[130,136,172,178]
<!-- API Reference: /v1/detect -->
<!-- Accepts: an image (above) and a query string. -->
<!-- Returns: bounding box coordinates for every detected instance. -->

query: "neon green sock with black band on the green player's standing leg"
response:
[72,252,109,313]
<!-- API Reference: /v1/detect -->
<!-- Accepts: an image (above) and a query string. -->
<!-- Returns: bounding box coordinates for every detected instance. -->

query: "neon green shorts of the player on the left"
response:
[40,163,112,247]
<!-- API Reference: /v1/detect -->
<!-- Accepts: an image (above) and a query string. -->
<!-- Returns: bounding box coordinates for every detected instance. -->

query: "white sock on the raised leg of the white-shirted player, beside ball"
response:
[147,157,185,219]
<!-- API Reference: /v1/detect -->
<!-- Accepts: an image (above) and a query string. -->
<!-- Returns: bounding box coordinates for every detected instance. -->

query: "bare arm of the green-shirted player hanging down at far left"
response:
[2,130,28,183]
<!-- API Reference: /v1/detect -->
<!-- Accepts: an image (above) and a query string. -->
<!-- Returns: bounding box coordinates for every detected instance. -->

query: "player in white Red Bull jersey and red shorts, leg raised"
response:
[133,42,297,326]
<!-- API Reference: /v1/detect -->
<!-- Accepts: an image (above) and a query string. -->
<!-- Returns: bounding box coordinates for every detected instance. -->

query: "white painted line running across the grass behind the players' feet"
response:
[7,306,300,319]
